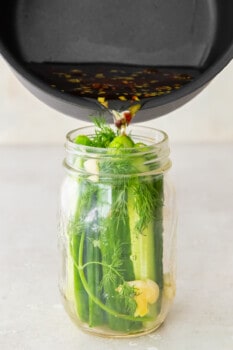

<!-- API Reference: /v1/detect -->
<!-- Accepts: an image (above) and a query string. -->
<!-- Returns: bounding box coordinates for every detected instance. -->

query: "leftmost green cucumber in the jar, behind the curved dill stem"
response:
[69,179,103,327]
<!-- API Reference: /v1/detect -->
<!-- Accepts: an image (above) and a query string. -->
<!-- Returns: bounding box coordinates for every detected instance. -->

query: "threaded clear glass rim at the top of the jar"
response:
[64,125,171,177]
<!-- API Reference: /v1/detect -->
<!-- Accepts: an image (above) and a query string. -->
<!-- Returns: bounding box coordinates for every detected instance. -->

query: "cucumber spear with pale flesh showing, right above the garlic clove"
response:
[128,176,163,317]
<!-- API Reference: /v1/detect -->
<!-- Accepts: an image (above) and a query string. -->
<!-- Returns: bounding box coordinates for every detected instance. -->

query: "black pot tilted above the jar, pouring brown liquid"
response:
[0,0,233,121]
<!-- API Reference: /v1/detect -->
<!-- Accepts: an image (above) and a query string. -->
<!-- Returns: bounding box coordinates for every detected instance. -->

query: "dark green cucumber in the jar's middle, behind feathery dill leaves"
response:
[99,183,141,332]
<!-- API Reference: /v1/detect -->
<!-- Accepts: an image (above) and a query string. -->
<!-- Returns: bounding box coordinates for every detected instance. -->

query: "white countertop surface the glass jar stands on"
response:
[0,144,233,350]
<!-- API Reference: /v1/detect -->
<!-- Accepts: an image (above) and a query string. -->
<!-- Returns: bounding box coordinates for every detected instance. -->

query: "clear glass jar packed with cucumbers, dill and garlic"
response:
[59,126,176,337]
